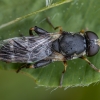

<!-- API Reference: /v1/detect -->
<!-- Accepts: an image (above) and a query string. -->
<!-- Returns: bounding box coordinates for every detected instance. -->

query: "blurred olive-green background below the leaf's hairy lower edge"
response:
[0,71,100,100]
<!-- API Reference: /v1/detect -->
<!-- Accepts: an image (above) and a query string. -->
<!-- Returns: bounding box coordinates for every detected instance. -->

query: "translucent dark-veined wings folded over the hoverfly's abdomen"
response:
[0,36,52,63]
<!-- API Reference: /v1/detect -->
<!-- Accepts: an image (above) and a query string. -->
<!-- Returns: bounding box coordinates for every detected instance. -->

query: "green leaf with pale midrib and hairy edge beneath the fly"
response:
[0,0,100,88]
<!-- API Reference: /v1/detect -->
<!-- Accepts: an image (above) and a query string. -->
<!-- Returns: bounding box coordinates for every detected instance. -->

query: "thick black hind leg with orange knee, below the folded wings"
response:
[16,60,52,73]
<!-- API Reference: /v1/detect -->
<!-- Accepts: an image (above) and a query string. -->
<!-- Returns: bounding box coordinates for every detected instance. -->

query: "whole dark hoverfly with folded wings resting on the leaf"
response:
[0,19,100,86]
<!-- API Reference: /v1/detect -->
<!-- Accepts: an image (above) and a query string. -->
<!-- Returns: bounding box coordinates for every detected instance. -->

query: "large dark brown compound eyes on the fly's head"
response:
[85,31,99,57]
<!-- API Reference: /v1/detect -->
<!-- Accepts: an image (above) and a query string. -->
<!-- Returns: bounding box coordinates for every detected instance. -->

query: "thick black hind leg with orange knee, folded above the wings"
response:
[29,26,48,36]
